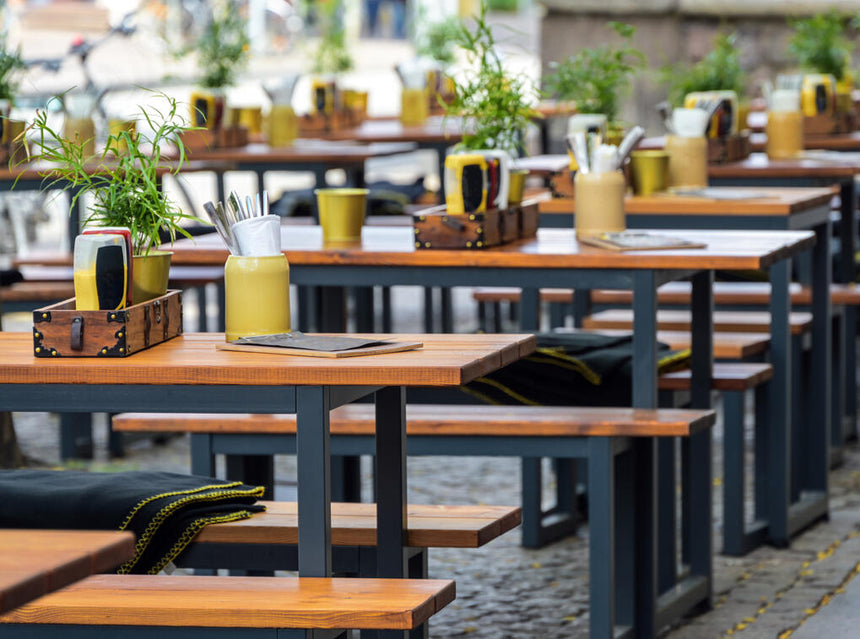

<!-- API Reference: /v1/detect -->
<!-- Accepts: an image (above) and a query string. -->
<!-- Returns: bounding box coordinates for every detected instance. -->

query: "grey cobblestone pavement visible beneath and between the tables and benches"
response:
[10,290,860,639]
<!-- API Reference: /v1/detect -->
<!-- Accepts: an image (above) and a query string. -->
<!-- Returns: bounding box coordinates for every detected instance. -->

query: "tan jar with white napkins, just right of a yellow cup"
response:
[666,109,708,188]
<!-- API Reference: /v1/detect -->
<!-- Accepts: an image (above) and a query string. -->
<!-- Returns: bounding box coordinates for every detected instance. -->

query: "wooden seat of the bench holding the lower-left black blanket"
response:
[194,502,522,548]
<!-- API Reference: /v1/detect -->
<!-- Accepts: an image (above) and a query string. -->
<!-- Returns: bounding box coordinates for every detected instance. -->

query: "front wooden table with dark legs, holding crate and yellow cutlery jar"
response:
[0,333,535,592]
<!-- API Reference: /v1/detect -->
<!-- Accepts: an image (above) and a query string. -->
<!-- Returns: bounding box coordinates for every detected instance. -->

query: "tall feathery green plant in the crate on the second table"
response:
[442,0,536,156]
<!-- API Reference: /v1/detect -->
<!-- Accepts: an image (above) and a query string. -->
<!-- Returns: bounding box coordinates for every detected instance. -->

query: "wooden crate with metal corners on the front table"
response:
[33,291,182,357]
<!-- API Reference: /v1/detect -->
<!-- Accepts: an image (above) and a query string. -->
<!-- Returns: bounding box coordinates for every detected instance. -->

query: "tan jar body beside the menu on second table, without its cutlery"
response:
[573,171,627,237]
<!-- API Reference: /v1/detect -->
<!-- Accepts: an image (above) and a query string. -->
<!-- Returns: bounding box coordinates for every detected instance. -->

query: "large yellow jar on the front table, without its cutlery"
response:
[224,255,290,342]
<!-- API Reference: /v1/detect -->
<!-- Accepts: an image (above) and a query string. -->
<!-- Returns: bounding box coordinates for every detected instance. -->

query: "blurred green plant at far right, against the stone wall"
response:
[788,10,852,80]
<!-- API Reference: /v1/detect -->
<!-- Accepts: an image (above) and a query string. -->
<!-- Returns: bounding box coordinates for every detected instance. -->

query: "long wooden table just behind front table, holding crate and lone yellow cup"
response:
[174,227,830,636]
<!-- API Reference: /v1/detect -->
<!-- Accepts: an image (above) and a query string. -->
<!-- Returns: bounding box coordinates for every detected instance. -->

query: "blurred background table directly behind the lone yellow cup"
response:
[186,138,416,202]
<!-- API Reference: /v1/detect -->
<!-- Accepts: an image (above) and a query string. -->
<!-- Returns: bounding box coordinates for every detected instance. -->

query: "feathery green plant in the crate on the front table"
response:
[21,93,200,255]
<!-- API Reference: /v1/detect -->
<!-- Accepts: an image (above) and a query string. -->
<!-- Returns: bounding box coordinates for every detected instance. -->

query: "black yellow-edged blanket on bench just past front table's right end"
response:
[460,332,690,406]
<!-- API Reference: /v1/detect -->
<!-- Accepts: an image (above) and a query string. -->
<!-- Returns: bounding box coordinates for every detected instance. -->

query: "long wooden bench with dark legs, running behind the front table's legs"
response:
[115,404,715,632]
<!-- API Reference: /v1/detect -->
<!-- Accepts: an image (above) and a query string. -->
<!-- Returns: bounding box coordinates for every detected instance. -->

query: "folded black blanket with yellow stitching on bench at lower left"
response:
[0,470,264,574]
